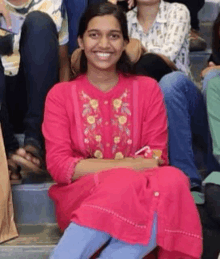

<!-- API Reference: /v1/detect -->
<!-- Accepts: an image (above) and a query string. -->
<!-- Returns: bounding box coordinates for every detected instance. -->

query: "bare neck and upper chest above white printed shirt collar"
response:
[137,2,160,32]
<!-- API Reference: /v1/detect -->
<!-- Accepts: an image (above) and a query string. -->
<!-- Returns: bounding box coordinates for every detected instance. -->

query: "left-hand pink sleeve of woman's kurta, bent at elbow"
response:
[42,83,83,184]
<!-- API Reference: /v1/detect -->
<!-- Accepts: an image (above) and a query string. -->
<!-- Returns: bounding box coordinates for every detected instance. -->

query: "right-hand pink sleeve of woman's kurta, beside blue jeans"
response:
[141,80,168,165]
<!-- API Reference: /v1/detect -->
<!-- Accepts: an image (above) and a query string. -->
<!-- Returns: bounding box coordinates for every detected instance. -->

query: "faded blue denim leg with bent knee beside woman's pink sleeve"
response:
[159,72,204,187]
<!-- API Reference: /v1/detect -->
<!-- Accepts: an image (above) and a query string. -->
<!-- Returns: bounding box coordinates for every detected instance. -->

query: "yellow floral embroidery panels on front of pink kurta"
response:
[79,89,133,159]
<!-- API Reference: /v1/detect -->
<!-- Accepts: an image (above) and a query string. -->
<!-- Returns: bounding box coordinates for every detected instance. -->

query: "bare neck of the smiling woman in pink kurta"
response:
[87,68,118,92]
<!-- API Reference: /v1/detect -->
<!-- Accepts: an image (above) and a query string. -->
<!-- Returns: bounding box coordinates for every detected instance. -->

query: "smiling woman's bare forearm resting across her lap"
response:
[73,157,158,180]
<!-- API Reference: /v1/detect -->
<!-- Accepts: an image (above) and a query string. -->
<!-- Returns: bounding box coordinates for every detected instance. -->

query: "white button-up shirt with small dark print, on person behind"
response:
[127,0,193,75]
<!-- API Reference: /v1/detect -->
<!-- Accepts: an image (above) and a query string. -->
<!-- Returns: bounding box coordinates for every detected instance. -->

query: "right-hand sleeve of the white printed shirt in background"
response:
[147,4,190,61]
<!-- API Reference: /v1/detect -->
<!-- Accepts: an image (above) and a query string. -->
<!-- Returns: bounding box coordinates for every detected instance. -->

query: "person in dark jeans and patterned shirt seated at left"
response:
[0,0,70,182]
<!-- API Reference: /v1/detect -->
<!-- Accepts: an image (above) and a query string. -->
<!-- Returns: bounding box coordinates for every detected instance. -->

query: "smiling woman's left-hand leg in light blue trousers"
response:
[50,223,111,259]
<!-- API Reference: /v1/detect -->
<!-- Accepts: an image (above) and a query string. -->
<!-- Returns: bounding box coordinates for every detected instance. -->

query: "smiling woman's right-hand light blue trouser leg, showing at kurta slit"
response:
[99,214,157,259]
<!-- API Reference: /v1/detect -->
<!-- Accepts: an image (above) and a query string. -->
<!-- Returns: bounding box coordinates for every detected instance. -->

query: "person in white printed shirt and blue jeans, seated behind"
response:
[109,0,210,196]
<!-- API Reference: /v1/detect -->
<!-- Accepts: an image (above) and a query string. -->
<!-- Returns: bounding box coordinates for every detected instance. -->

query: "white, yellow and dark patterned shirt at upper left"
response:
[0,0,69,76]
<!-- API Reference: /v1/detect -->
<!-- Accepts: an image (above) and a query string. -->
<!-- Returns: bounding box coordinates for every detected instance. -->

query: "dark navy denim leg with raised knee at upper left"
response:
[20,11,59,150]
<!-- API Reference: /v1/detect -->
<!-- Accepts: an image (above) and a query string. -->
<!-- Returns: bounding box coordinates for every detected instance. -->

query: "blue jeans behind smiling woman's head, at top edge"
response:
[64,0,106,54]
